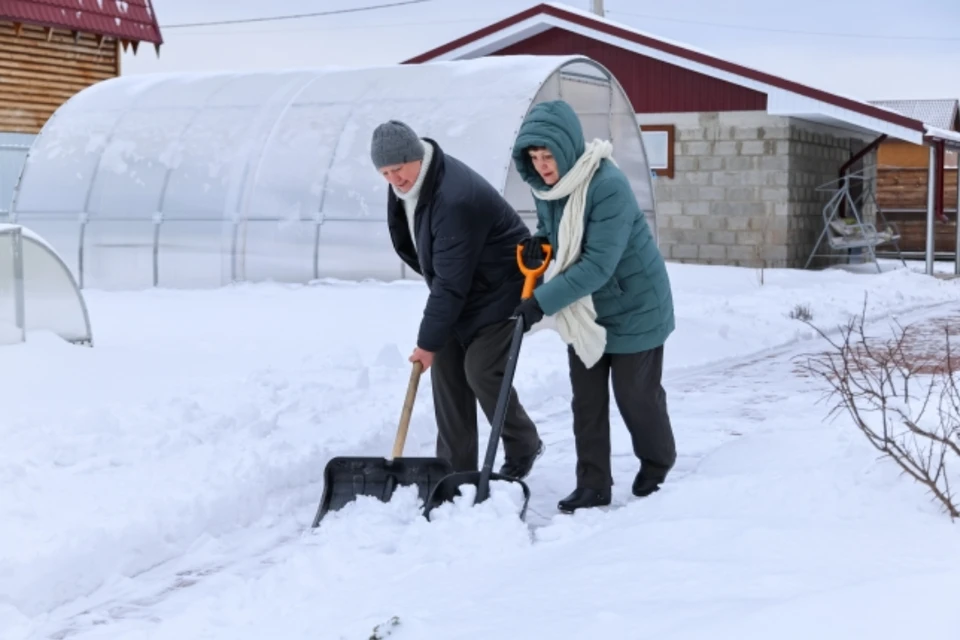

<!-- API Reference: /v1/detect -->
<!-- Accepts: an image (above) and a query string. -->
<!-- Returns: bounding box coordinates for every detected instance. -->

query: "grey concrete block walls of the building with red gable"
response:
[637,111,865,267]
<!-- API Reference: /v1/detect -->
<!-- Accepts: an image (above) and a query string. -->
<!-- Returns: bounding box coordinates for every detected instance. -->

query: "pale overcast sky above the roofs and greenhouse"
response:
[122,0,960,100]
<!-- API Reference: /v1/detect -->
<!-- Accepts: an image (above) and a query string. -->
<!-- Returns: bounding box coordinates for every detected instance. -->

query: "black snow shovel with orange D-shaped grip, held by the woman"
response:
[423,244,552,520]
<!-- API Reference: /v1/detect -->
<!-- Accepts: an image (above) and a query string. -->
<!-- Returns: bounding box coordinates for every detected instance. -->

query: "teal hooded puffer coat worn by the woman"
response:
[513,100,675,353]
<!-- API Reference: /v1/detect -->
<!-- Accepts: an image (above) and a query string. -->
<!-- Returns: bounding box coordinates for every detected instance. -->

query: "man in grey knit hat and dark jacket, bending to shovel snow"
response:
[370,120,543,478]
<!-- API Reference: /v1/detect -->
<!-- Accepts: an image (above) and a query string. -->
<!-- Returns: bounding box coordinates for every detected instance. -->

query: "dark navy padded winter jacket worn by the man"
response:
[387,138,530,352]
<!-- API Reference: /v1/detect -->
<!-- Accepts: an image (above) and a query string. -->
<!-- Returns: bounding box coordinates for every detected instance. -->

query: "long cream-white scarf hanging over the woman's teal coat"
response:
[533,139,616,369]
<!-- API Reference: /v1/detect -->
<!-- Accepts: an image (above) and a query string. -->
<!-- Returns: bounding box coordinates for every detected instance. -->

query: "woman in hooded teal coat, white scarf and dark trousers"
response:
[513,100,676,512]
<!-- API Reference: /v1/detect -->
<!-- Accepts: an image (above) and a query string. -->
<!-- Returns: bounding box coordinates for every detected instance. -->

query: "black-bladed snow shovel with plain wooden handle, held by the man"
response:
[313,362,453,527]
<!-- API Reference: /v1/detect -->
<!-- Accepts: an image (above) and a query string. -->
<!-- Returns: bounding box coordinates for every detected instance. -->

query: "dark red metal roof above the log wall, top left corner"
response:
[0,0,163,45]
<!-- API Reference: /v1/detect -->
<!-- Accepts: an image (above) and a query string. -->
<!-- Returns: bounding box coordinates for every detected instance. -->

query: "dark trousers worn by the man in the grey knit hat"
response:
[431,320,540,471]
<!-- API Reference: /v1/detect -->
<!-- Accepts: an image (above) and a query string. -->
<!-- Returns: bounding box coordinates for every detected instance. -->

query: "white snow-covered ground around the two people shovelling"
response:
[0,264,960,640]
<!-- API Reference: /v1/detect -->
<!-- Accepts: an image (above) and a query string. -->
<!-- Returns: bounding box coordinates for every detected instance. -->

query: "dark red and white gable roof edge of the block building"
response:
[405,2,924,143]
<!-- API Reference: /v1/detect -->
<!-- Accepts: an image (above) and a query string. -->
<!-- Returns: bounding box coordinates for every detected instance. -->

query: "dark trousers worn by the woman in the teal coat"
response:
[568,346,677,490]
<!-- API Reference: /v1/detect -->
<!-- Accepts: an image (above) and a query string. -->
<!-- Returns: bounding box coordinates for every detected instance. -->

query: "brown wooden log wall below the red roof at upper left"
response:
[0,21,120,133]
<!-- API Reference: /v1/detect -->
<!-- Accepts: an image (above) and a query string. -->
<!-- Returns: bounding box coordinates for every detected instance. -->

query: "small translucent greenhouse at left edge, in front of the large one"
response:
[0,224,93,346]
